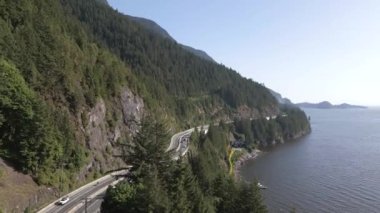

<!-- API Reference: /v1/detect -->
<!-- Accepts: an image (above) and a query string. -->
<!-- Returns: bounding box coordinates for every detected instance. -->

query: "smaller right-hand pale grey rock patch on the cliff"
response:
[120,88,144,132]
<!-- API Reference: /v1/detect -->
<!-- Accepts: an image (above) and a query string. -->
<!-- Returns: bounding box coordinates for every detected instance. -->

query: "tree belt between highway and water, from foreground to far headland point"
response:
[102,109,310,212]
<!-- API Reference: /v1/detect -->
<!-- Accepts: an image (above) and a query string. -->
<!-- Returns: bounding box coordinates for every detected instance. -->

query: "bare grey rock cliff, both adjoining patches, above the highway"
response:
[78,88,144,179]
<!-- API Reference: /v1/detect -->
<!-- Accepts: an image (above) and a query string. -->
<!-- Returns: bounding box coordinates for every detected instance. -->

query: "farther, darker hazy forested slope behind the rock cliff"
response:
[61,0,277,122]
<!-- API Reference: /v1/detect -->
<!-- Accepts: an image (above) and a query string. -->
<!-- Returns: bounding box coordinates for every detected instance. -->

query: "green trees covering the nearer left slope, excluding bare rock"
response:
[0,0,128,189]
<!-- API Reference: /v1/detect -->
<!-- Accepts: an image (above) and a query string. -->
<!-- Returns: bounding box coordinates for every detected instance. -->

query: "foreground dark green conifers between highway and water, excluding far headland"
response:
[102,119,266,212]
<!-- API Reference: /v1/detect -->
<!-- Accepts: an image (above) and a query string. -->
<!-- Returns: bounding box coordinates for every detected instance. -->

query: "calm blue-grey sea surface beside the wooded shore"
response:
[240,109,380,213]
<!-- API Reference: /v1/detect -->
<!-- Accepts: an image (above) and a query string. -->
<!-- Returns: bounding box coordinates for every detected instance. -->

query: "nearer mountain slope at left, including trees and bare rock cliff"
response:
[0,0,140,198]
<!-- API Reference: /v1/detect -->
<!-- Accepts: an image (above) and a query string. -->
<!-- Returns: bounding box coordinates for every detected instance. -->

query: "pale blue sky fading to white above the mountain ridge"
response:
[108,0,380,106]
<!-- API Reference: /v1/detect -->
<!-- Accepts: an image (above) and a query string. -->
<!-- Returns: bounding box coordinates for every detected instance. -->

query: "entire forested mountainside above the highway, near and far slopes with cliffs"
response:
[0,0,308,211]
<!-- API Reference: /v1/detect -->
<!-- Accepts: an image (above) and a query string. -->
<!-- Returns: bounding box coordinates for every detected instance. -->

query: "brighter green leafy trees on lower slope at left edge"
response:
[0,59,85,184]
